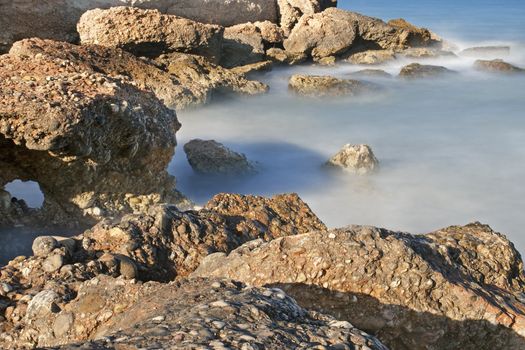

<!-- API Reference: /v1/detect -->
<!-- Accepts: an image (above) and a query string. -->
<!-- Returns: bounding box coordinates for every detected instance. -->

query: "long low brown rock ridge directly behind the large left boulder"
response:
[10,39,268,109]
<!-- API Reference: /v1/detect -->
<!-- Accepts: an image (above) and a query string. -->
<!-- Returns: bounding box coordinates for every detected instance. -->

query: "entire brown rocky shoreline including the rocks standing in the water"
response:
[0,0,525,350]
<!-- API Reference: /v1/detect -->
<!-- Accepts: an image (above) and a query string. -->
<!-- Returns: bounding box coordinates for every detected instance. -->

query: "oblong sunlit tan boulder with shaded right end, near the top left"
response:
[77,7,224,63]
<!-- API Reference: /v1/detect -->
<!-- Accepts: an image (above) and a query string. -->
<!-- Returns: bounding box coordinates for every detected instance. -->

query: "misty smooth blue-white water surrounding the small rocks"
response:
[170,43,525,251]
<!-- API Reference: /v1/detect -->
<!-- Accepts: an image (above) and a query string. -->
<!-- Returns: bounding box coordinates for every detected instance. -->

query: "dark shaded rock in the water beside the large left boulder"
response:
[184,139,256,175]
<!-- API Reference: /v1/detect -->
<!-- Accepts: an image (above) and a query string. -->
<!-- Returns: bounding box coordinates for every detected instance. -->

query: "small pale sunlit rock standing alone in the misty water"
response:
[326,144,379,175]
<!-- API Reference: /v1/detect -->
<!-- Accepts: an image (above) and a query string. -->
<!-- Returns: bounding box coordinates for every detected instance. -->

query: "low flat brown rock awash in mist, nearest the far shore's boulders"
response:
[288,74,373,97]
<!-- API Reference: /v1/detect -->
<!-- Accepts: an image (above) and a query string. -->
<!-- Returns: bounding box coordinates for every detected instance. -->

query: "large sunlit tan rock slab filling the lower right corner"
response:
[193,223,525,350]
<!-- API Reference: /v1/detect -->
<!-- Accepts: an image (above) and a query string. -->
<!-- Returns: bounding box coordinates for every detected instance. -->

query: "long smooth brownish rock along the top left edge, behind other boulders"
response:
[0,0,278,53]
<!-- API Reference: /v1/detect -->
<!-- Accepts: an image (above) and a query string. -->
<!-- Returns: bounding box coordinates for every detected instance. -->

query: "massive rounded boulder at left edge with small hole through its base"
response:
[0,50,181,227]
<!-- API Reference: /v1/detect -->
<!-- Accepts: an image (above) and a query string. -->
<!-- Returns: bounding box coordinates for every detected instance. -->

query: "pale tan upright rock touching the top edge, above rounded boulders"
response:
[277,0,337,36]
